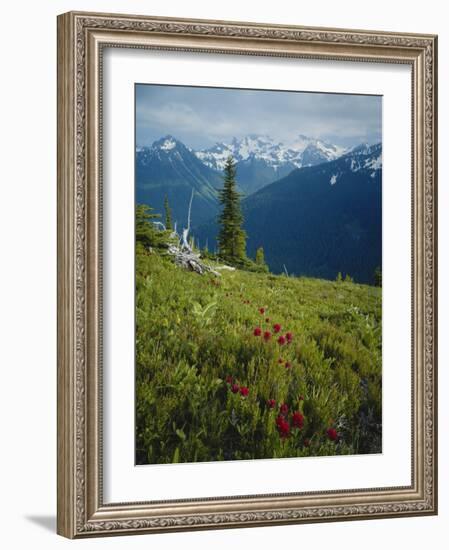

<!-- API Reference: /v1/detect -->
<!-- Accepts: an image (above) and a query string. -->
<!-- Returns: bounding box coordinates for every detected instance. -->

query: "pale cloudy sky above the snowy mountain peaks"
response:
[136,84,382,149]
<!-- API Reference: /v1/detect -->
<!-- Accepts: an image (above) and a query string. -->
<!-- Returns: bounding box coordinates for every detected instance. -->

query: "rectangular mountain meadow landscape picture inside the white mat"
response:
[135,84,382,464]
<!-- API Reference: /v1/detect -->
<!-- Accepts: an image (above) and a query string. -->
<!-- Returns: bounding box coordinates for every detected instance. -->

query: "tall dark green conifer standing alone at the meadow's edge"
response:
[217,156,246,264]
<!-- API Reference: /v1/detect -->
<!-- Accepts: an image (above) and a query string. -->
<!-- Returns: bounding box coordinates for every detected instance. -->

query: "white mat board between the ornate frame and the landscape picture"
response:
[103,48,411,502]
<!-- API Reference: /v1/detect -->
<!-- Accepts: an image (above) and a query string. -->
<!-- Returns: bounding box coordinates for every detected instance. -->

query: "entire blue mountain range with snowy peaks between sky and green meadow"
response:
[136,135,382,284]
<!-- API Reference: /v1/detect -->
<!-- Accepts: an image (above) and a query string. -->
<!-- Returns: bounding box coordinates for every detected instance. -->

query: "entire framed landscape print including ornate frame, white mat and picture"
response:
[58,12,437,538]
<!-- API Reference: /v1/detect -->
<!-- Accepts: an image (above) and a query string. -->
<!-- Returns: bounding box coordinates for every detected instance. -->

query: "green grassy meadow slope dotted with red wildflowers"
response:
[136,253,381,463]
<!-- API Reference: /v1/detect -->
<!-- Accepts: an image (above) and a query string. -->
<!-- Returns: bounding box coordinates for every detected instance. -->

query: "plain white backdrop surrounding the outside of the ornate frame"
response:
[0,0,449,550]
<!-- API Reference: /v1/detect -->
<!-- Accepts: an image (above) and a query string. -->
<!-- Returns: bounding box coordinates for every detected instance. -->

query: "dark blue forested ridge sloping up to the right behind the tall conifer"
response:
[193,144,382,283]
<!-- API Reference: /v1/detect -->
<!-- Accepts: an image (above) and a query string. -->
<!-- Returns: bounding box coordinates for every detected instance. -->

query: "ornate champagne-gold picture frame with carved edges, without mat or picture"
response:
[57,12,437,538]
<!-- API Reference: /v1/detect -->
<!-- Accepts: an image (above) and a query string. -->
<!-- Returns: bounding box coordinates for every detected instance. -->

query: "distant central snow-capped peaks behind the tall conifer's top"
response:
[195,134,345,195]
